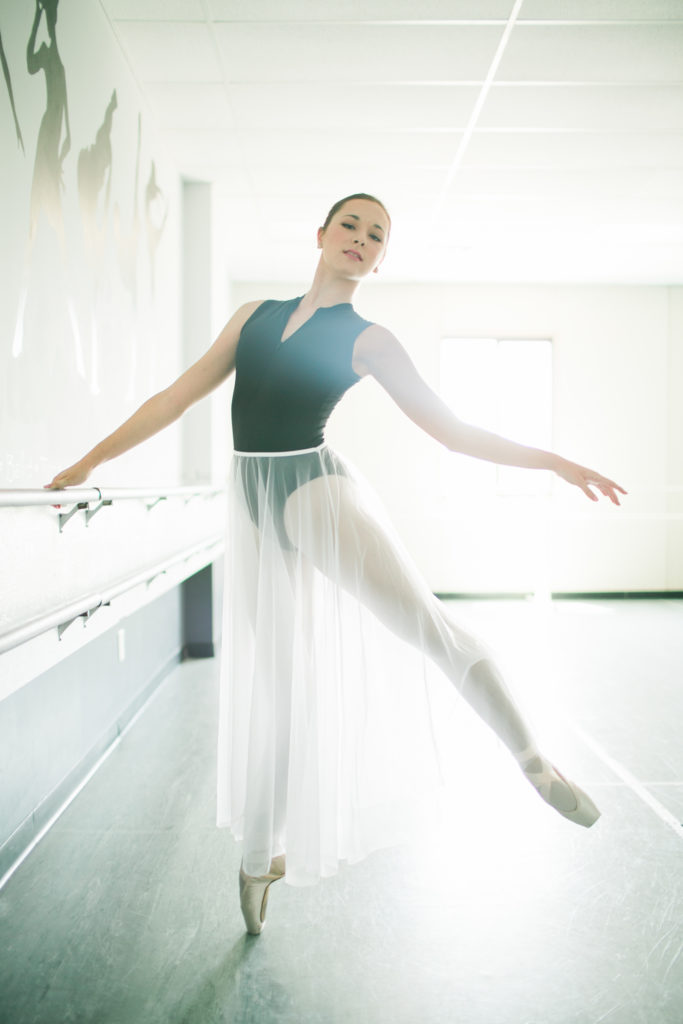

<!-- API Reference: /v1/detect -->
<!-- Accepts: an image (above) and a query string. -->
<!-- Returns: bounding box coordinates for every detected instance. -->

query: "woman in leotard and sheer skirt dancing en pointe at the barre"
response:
[48,194,626,934]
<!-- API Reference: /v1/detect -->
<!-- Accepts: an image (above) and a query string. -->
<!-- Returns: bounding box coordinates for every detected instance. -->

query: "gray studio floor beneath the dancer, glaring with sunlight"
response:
[0,600,683,1024]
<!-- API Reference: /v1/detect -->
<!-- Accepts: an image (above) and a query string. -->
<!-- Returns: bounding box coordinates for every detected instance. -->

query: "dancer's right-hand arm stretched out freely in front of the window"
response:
[353,325,626,505]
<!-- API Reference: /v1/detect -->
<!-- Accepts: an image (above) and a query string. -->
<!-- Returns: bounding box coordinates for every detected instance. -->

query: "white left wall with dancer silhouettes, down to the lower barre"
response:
[0,6,222,675]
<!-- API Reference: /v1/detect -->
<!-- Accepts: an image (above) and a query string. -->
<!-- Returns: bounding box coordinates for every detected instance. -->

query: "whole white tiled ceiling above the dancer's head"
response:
[100,0,683,284]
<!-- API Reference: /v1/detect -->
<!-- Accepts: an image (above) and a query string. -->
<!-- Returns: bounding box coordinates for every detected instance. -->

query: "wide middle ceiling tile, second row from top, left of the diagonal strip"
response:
[214,24,502,84]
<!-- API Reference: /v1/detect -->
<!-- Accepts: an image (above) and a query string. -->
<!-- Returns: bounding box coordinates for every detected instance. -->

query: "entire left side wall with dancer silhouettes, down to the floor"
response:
[0,0,225,873]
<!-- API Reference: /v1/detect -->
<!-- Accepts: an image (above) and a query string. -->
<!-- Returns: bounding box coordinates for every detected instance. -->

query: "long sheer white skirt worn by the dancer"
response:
[217,445,521,886]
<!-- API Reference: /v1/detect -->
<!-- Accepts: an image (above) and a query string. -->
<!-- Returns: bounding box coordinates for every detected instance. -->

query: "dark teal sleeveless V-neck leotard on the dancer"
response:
[231,296,372,549]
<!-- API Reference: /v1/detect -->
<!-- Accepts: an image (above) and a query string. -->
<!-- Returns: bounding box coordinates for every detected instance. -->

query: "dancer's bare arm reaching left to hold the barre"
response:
[46,302,259,488]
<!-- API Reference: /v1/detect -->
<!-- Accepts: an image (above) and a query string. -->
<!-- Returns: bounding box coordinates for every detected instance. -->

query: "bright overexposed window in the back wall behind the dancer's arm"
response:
[440,338,553,497]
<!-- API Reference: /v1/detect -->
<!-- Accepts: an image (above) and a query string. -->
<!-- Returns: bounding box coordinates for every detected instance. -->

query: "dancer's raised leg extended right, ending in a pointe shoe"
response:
[285,476,599,825]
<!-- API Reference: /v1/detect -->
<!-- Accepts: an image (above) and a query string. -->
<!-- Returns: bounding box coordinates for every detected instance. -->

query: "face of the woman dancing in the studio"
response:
[317,199,389,279]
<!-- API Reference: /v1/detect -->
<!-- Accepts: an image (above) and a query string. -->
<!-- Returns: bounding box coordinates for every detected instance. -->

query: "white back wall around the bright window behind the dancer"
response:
[232,282,683,593]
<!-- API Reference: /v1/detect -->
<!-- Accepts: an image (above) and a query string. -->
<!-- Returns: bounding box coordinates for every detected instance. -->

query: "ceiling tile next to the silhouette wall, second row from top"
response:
[112,22,222,82]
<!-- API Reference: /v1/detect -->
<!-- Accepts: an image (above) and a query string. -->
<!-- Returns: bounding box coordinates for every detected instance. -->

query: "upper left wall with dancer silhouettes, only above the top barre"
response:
[0,0,180,486]
